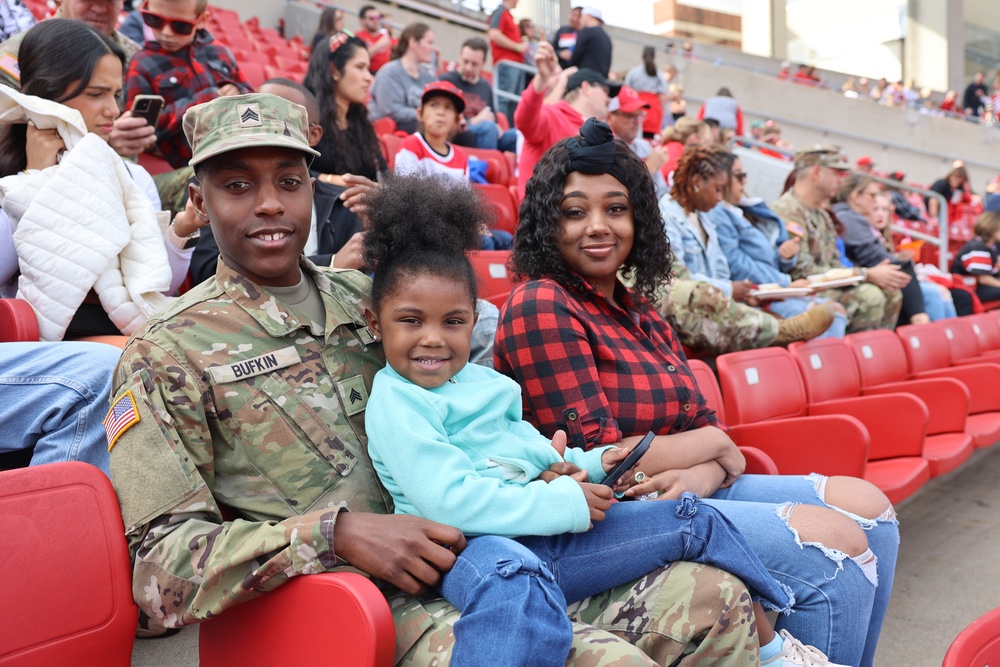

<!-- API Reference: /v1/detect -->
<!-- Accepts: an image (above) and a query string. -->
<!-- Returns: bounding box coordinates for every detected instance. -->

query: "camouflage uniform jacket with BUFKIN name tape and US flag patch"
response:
[111,259,444,651]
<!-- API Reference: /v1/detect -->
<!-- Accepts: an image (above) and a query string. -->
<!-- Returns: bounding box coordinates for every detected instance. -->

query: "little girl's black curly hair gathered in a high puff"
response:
[362,175,491,313]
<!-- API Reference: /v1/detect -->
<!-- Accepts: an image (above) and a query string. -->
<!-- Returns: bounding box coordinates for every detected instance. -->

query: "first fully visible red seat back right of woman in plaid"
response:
[716,347,806,424]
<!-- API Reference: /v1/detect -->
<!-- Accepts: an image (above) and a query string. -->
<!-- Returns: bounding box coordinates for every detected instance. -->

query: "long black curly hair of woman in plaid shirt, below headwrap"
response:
[510,139,674,299]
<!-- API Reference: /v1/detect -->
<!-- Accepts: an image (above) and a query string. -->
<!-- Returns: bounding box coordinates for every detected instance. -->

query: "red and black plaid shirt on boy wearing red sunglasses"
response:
[125,30,253,169]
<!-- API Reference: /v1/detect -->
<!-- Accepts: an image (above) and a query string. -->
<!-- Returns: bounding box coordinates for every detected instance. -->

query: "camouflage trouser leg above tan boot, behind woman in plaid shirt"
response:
[659,278,778,354]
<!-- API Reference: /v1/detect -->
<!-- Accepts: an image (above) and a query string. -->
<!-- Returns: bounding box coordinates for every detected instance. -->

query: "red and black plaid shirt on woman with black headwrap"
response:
[493,279,718,449]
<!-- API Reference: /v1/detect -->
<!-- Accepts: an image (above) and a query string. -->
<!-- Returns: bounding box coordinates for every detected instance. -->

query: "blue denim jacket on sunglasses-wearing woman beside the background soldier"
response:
[706,202,792,287]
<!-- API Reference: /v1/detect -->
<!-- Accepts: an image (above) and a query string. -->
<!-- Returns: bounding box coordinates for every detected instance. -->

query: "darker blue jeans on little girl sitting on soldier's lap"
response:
[441,493,792,667]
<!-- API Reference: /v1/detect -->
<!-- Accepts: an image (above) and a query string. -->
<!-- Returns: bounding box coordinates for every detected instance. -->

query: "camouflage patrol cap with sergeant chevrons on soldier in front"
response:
[184,93,319,167]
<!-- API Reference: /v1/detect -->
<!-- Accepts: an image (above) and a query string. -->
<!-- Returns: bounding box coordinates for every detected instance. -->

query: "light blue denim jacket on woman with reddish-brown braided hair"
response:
[660,196,733,296]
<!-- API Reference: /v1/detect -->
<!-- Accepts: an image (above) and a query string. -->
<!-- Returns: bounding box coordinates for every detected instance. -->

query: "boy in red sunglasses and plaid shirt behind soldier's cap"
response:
[125,0,253,169]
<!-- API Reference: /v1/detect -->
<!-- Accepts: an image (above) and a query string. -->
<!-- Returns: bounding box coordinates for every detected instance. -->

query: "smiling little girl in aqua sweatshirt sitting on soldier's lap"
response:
[365,177,844,665]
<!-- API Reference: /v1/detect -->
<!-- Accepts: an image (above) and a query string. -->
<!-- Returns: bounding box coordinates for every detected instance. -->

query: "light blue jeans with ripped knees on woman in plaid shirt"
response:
[704,475,899,667]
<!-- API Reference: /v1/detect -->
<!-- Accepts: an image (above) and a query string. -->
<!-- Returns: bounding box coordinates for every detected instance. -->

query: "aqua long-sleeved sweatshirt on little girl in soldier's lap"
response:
[365,364,609,537]
